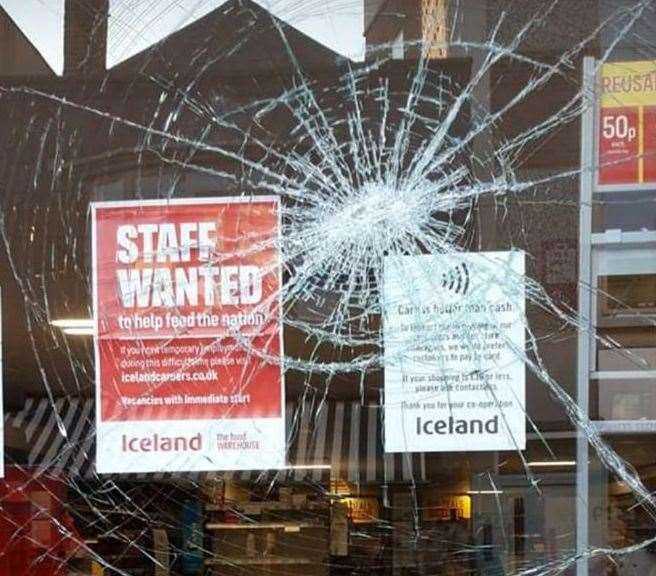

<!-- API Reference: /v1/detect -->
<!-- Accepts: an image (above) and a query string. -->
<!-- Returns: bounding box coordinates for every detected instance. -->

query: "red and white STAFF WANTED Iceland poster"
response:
[92,196,285,473]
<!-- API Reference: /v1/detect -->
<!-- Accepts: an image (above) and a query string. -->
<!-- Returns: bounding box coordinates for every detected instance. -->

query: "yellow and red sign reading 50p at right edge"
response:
[598,60,656,186]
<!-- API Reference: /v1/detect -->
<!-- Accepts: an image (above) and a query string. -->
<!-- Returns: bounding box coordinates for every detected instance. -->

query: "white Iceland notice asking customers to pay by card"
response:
[383,251,526,452]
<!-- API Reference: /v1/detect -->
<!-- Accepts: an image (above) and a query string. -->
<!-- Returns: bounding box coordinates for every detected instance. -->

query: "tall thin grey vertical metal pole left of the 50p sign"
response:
[576,57,597,576]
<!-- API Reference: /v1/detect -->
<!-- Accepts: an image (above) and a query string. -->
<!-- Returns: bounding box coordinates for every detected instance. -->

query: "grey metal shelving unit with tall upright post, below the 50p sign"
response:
[576,57,656,576]
